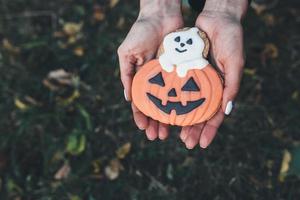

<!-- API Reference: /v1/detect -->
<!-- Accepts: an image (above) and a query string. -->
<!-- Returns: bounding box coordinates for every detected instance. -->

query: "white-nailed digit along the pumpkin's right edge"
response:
[222,58,244,115]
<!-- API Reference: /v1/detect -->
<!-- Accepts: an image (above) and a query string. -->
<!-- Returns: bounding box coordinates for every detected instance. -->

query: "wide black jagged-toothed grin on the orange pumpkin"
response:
[147,93,205,115]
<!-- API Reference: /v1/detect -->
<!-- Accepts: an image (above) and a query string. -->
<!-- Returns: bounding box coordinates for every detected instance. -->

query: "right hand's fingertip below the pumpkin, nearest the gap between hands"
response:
[184,123,204,149]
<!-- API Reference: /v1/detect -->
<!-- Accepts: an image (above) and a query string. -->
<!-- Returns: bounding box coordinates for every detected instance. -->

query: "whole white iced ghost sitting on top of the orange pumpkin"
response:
[159,27,209,77]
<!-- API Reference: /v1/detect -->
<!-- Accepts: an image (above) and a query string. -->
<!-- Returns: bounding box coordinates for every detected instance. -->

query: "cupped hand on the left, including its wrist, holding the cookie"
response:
[118,0,183,140]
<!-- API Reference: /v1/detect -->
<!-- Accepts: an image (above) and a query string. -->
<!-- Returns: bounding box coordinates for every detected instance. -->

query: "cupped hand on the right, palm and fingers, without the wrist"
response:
[180,3,244,149]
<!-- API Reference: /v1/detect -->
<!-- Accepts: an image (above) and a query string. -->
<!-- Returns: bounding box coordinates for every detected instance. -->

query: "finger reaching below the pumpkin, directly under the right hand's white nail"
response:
[199,110,224,148]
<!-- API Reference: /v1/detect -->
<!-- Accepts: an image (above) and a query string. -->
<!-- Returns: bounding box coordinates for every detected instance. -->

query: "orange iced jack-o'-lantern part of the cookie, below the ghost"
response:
[132,60,222,126]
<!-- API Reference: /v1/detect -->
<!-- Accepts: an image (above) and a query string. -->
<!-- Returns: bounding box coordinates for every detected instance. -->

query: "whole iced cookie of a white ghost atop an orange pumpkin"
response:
[132,28,223,126]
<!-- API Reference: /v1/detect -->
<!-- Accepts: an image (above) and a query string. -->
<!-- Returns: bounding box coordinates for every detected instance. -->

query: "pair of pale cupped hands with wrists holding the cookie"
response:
[118,0,248,149]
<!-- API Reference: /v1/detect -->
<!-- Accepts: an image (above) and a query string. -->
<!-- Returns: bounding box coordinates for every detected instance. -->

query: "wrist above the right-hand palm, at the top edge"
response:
[203,0,248,21]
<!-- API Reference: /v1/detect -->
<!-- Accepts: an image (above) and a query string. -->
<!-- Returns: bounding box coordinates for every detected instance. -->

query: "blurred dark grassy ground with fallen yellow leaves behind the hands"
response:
[0,0,300,200]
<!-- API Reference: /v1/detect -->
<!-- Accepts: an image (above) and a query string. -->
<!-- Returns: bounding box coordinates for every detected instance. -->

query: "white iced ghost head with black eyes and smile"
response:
[163,28,205,64]
